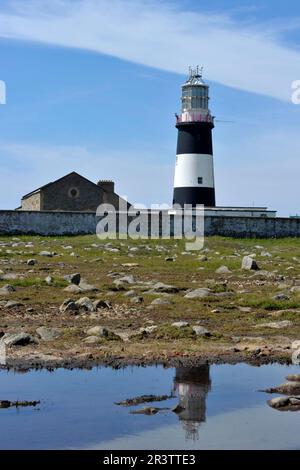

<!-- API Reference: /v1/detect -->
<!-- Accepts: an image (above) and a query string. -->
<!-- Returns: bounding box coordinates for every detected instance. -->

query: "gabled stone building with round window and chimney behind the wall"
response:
[16,171,127,212]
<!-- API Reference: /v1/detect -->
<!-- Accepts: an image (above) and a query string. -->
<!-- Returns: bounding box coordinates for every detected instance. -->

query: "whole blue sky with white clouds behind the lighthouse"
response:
[0,0,300,215]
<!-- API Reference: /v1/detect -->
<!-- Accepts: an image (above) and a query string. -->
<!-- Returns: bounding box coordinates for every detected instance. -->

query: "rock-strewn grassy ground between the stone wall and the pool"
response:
[0,236,300,359]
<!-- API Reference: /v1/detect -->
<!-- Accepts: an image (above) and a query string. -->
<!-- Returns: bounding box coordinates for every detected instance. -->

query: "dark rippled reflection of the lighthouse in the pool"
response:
[174,364,211,440]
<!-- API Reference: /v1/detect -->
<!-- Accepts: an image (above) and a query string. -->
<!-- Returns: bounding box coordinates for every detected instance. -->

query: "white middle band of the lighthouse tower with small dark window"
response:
[174,153,215,188]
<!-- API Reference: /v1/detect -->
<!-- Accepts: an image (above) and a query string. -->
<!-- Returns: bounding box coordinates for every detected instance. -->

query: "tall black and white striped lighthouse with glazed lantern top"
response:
[173,67,216,207]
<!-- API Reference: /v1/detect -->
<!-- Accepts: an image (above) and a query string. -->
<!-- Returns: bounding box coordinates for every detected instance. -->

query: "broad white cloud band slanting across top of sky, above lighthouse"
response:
[0,0,300,101]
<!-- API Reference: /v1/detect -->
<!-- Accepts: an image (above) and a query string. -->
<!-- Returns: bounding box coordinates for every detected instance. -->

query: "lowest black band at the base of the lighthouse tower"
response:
[173,187,216,207]
